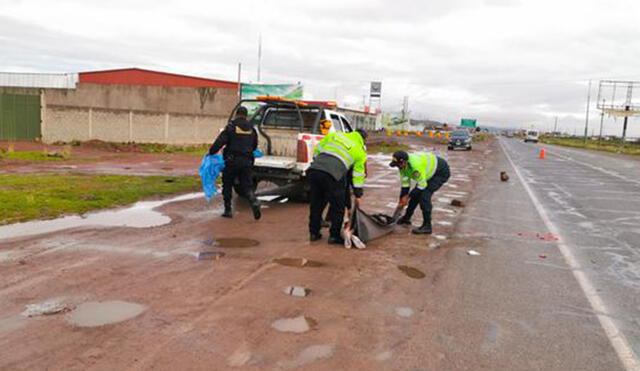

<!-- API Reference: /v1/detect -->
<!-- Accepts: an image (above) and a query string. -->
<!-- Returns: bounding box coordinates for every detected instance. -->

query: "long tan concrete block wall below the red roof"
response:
[42,84,237,144]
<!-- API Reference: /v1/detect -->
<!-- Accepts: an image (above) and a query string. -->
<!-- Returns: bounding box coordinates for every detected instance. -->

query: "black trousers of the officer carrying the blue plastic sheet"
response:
[222,160,257,209]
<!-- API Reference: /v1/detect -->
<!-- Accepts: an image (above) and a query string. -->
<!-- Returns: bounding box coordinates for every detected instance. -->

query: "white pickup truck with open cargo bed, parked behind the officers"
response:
[231,97,353,201]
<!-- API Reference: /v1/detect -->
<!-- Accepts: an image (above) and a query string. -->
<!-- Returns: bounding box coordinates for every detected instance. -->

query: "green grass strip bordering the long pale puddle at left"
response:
[0,174,200,225]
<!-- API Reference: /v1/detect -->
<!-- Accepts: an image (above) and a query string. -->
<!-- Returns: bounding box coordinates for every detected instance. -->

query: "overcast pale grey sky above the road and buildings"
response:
[0,0,640,135]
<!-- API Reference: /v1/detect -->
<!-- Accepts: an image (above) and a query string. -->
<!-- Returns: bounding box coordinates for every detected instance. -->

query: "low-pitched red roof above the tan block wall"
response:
[79,68,238,89]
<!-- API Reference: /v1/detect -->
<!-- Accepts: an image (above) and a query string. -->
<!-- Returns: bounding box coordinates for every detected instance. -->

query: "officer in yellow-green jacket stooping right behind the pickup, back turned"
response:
[307,129,367,245]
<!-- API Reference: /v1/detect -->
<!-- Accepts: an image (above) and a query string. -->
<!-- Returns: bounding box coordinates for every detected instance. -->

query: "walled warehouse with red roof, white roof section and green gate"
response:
[0,68,238,144]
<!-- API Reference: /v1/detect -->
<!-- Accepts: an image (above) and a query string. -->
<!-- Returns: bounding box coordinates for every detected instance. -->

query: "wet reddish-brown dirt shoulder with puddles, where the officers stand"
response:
[0,138,496,370]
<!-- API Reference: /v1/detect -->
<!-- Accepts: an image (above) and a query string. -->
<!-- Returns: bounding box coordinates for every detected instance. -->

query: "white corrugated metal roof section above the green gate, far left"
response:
[0,72,78,89]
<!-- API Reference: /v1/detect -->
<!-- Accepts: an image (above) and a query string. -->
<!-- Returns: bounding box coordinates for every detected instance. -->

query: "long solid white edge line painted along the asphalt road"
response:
[499,139,640,370]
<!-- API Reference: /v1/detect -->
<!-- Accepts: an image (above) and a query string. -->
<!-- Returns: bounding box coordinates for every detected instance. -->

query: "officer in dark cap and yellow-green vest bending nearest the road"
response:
[389,151,451,234]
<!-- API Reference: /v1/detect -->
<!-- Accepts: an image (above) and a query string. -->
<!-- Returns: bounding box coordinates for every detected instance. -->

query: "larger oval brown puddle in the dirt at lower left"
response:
[67,300,146,327]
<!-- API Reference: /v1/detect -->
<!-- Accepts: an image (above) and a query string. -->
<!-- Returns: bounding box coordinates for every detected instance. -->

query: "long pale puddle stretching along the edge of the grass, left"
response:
[0,193,202,240]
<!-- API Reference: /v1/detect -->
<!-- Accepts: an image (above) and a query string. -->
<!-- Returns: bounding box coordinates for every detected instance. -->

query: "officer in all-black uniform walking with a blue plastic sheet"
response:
[209,106,261,219]
